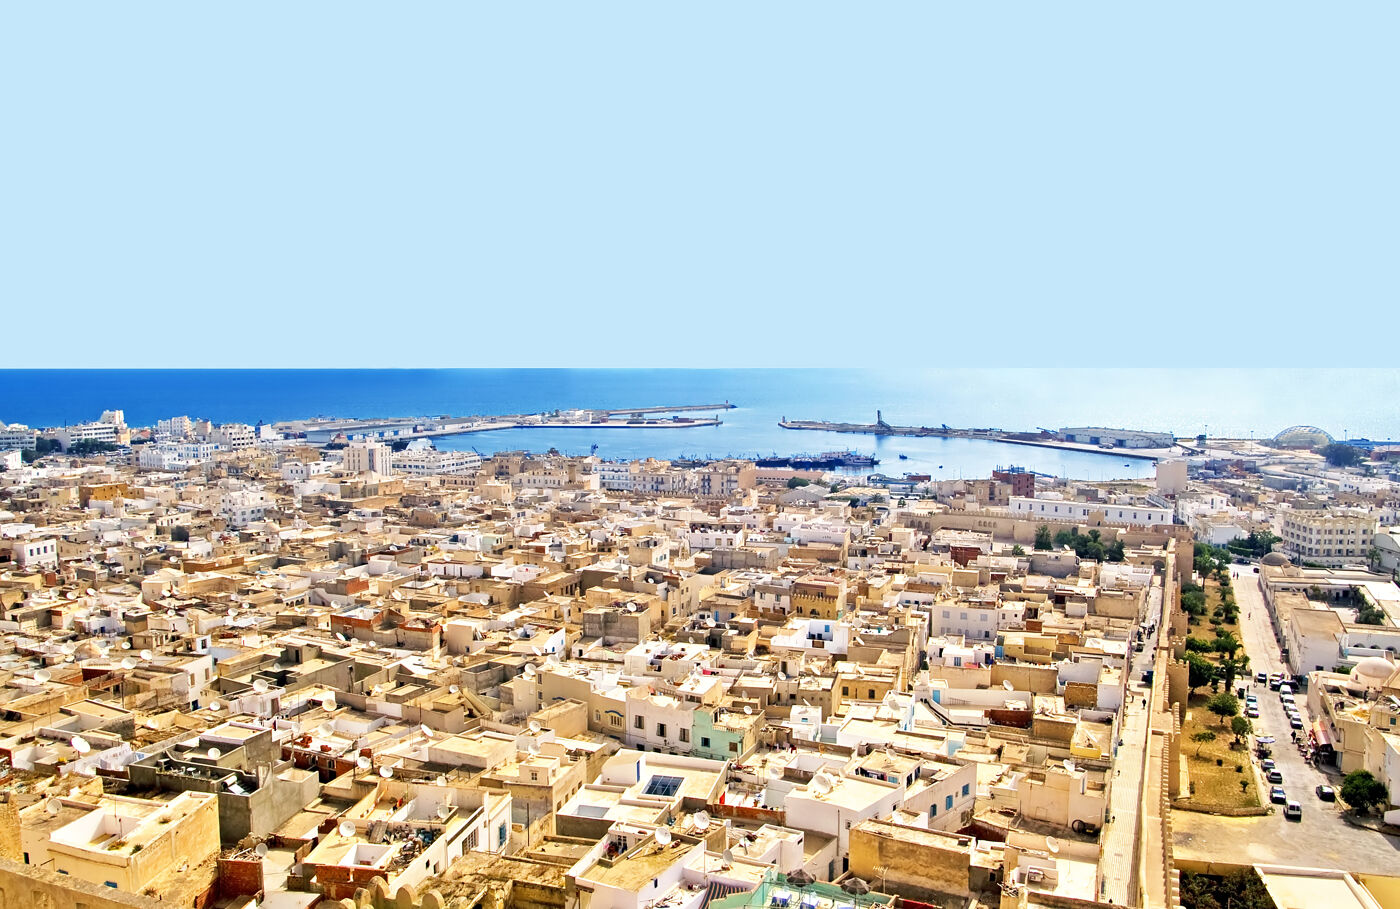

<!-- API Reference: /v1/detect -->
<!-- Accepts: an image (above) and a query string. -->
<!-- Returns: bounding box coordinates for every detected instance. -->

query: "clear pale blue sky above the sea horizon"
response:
[0,0,1400,367]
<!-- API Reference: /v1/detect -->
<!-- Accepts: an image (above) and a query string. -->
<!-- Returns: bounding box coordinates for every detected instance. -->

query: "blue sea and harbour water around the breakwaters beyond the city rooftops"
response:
[0,369,1400,480]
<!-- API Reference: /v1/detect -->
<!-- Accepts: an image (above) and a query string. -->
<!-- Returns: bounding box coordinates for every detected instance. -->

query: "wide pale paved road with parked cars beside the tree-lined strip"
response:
[1172,566,1400,874]
